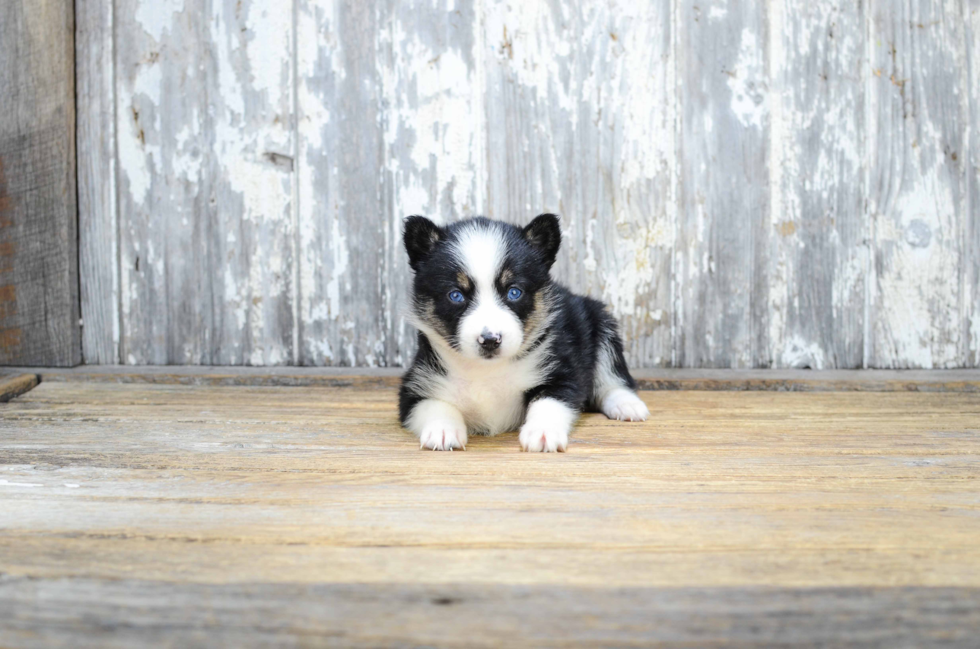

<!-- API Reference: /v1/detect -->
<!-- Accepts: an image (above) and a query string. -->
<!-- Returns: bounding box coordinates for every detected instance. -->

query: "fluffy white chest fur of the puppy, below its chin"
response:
[433,348,546,435]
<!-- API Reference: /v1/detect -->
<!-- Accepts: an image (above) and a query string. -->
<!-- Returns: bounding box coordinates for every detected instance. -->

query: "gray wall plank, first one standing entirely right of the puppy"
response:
[674,2,772,367]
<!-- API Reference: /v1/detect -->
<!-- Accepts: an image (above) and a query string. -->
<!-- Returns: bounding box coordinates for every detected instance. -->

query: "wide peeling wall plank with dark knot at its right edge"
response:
[115,0,296,364]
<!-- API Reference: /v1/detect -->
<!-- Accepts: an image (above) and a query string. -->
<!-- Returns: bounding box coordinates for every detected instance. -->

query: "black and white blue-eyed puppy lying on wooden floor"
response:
[399,214,650,452]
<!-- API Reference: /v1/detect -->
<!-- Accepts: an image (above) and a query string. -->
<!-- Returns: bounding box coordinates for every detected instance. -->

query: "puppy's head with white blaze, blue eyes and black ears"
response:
[405,214,561,360]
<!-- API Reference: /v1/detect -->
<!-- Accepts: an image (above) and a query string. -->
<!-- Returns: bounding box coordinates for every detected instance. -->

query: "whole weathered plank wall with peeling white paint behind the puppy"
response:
[78,0,980,368]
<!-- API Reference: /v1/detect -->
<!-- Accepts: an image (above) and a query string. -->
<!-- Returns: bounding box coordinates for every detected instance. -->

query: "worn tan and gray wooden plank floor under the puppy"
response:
[0,381,980,647]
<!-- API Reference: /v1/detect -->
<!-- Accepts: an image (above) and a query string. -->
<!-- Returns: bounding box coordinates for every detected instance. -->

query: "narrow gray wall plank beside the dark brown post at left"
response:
[75,0,119,364]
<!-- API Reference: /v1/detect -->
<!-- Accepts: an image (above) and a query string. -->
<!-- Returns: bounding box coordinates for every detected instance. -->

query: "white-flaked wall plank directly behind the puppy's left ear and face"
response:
[378,2,487,366]
